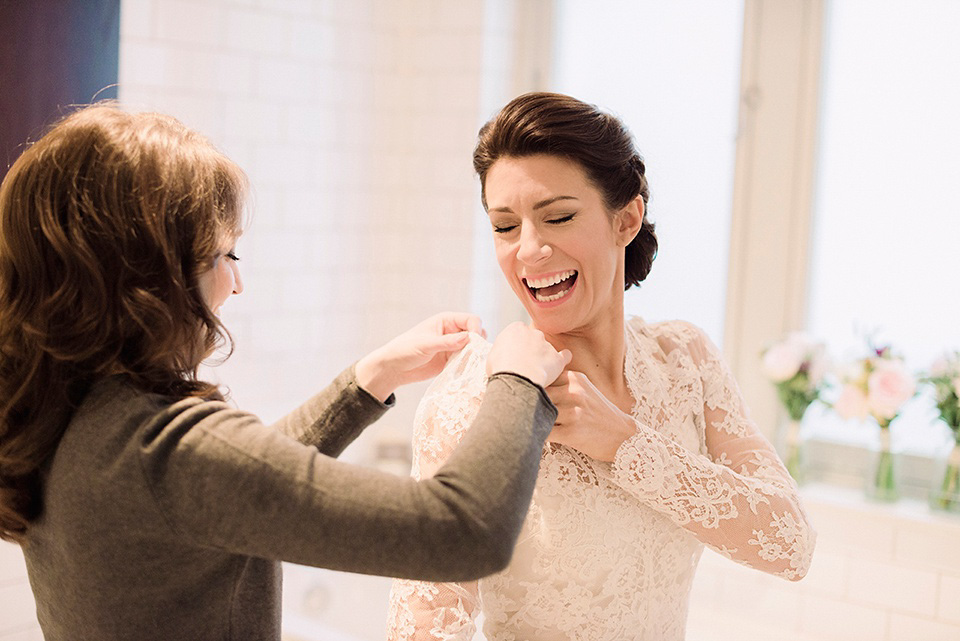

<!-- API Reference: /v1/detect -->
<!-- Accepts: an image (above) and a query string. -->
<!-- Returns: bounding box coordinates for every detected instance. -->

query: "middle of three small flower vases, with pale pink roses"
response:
[833,346,917,501]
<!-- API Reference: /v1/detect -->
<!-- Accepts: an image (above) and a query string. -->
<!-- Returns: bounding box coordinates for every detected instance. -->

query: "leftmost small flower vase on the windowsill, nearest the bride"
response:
[763,332,827,483]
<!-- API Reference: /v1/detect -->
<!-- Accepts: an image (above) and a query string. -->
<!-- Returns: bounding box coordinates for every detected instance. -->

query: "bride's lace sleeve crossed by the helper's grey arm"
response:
[387,337,490,641]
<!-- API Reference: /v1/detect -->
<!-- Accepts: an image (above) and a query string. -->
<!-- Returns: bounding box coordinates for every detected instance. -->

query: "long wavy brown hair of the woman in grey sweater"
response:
[0,104,247,543]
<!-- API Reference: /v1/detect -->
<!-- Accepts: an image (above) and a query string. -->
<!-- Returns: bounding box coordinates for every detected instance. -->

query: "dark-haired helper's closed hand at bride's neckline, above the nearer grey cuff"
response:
[487,321,571,387]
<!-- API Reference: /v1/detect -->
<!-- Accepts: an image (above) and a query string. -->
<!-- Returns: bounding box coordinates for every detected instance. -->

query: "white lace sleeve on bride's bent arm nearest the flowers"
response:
[614,326,816,580]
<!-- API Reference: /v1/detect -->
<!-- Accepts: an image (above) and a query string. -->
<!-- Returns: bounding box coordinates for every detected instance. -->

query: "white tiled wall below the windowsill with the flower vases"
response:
[687,487,960,641]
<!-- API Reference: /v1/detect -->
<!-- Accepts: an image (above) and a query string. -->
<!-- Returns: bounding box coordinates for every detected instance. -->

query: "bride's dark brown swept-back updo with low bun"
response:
[473,92,657,290]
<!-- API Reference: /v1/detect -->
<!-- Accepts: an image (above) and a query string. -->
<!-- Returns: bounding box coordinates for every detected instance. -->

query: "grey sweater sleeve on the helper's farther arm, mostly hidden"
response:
[272,364,395,458]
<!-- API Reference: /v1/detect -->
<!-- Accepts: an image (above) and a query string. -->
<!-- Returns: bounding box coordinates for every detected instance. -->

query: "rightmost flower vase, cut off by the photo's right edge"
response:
[920,351,960,511]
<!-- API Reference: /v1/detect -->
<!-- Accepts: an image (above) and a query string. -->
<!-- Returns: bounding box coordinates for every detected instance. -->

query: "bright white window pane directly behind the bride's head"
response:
[553,0,743,343]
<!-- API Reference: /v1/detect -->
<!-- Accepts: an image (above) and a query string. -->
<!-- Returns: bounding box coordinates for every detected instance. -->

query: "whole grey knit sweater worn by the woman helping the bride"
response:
[24,368,556,641]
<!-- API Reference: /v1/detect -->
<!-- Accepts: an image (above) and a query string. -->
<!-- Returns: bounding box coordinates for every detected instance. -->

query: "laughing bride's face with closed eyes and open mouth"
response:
[484,155,635,334]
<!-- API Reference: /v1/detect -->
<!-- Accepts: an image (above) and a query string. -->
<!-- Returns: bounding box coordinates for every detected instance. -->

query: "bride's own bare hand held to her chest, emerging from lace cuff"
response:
[547,371,637,462]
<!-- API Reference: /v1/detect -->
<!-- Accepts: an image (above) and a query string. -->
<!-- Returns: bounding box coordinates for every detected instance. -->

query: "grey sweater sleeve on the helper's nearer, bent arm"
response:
[139,364,556,581]
